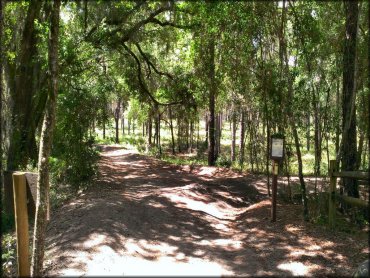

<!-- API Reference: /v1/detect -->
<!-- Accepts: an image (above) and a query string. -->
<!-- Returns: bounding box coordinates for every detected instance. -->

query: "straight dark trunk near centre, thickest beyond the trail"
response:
[208,35,216,166]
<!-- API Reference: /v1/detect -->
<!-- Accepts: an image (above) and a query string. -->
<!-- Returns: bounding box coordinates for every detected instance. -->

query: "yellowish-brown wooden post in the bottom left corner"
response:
[13,172,30,277]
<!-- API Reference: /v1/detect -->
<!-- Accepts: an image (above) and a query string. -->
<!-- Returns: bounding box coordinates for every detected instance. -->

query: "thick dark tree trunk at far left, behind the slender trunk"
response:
[7,1,44,170]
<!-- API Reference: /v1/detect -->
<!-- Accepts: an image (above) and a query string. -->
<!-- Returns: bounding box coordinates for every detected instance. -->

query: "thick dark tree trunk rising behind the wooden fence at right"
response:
[341,0,359,197]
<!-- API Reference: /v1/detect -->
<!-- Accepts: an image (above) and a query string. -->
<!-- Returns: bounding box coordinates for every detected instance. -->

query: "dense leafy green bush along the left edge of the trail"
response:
[51,86,99,187]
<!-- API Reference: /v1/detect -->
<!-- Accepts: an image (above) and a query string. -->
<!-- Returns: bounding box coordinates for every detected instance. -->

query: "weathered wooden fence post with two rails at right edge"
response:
[329,160,370,228]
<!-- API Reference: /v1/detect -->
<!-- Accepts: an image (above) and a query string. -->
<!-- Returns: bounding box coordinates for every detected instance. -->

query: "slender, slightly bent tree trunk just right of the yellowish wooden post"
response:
[31,0,60,277]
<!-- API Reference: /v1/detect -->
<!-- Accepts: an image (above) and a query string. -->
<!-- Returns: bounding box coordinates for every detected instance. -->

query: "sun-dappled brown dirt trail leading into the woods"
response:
[46,146,368,276]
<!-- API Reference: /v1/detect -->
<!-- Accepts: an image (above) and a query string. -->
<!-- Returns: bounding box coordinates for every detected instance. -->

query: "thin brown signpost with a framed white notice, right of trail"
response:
[270,134,284,222]
